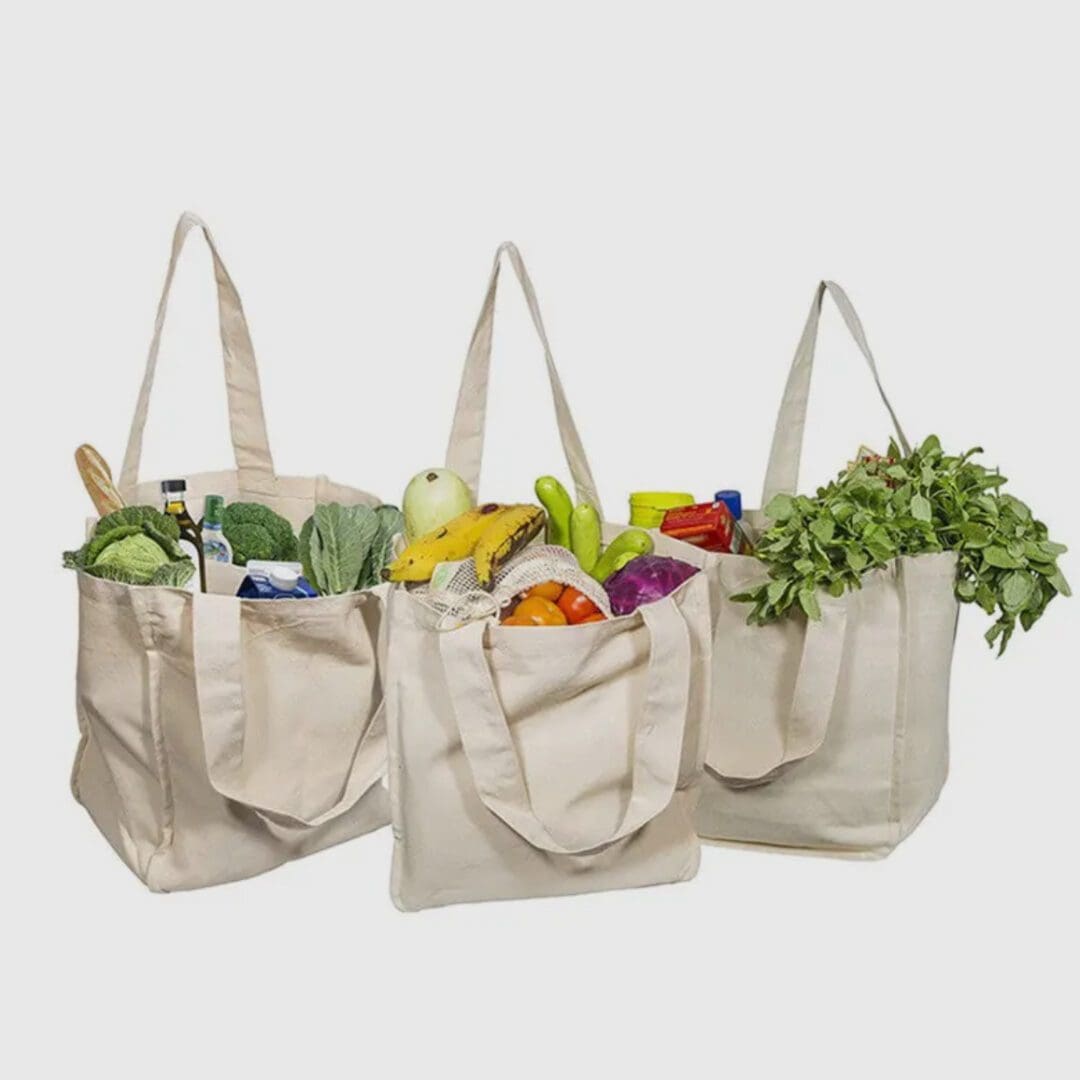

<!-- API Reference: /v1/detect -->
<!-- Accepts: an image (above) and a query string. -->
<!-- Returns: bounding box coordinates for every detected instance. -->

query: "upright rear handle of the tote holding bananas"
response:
[446,243,604,519]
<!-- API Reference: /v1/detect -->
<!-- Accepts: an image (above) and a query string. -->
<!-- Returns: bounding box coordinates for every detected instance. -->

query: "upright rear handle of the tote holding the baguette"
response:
[120,213,273,502]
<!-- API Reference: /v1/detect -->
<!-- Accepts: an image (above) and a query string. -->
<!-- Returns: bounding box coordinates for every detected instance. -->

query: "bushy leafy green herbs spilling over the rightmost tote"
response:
[733,435,1070,656]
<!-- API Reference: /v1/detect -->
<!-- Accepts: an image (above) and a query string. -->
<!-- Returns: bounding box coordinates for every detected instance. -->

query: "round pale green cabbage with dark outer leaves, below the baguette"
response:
[64,507,195,588]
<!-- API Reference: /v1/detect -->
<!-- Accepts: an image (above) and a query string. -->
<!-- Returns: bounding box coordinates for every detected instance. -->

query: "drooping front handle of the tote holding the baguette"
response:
[191,593,387,828]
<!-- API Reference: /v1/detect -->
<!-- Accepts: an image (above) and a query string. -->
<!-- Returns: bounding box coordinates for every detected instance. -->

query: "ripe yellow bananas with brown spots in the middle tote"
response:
[383,502,544,589]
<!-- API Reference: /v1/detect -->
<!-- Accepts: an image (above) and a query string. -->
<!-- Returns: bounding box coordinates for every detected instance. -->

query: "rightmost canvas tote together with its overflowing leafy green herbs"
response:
[698,282,1068,854]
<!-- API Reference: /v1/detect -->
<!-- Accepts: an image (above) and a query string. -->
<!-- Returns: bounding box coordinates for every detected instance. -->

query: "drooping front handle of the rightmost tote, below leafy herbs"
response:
[705,595,849,782]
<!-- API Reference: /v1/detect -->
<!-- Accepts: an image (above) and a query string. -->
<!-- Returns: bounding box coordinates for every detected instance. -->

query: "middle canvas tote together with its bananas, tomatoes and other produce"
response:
[386,245,711,909]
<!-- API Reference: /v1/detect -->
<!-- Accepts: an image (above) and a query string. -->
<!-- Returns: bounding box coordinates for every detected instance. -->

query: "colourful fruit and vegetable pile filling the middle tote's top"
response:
[393,469,697,626]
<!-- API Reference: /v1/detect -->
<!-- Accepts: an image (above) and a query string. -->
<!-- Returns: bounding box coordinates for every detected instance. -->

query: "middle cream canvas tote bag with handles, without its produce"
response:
[387,244,711,910]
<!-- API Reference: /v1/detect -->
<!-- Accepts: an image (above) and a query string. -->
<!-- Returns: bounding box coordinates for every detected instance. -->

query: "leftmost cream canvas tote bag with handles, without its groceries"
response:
[72,214,389,891]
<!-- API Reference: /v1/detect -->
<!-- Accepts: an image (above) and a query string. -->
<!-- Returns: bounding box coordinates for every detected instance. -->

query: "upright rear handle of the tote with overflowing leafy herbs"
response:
[761,281,910,507]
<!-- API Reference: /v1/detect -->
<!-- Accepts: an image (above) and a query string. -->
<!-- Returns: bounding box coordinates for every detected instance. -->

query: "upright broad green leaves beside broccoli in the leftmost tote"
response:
[298,502,404,596]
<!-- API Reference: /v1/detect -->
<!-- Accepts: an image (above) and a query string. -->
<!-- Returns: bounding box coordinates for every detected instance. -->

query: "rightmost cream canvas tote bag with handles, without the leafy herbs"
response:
[698,282,958,854]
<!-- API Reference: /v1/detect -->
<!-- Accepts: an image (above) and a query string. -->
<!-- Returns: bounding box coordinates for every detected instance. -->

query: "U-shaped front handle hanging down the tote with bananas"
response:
[438,596,691,855]
